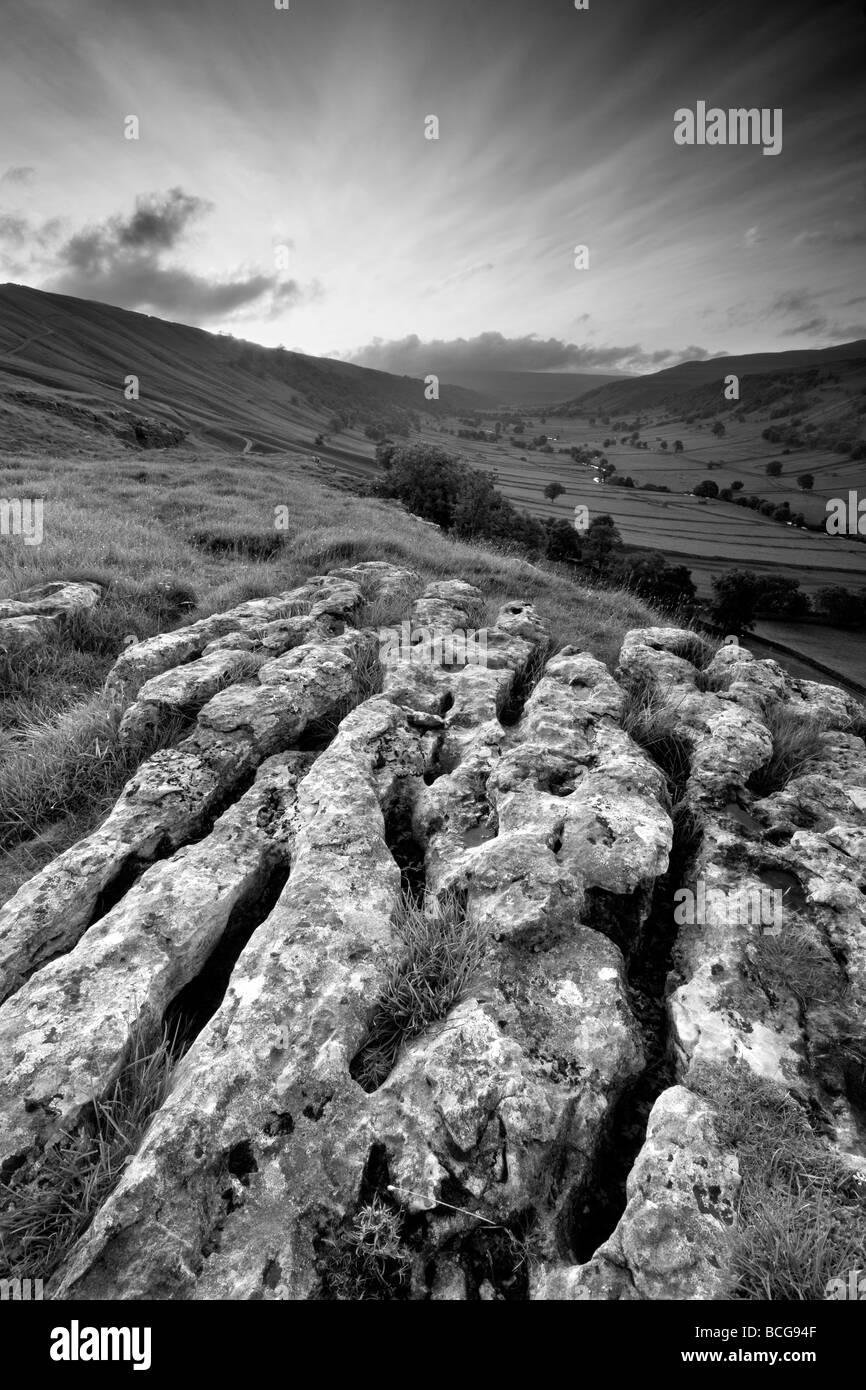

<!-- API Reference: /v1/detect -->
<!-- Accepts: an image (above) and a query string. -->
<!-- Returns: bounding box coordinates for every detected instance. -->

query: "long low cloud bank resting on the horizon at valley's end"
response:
[343,332,724,378]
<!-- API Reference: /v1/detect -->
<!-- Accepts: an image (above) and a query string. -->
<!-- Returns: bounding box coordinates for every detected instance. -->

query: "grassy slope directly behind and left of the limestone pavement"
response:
[0,450,655,902]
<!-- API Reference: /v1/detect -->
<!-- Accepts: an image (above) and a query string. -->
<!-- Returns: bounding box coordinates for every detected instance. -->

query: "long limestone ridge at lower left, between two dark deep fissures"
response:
[0,753,310,1169]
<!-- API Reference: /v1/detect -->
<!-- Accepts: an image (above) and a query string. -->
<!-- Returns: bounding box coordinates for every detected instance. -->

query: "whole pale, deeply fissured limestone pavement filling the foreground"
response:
[0,581,866,1300]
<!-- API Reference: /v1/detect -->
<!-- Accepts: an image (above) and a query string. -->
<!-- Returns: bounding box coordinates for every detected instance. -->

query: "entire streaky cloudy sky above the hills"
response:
[0,0,866,375]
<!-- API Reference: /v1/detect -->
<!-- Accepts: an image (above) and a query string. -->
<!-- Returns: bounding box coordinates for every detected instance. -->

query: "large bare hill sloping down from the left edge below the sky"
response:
[0,285,488,452]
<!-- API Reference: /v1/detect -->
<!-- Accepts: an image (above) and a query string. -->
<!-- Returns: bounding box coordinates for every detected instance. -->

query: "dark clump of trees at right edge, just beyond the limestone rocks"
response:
[710,570,866,634]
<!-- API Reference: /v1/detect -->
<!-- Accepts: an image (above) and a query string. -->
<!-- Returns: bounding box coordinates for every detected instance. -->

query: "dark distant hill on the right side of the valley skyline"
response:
[555,339,866,416]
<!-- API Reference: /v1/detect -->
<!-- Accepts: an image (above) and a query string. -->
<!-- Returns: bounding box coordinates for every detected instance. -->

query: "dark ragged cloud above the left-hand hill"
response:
[47,188,306,322]
